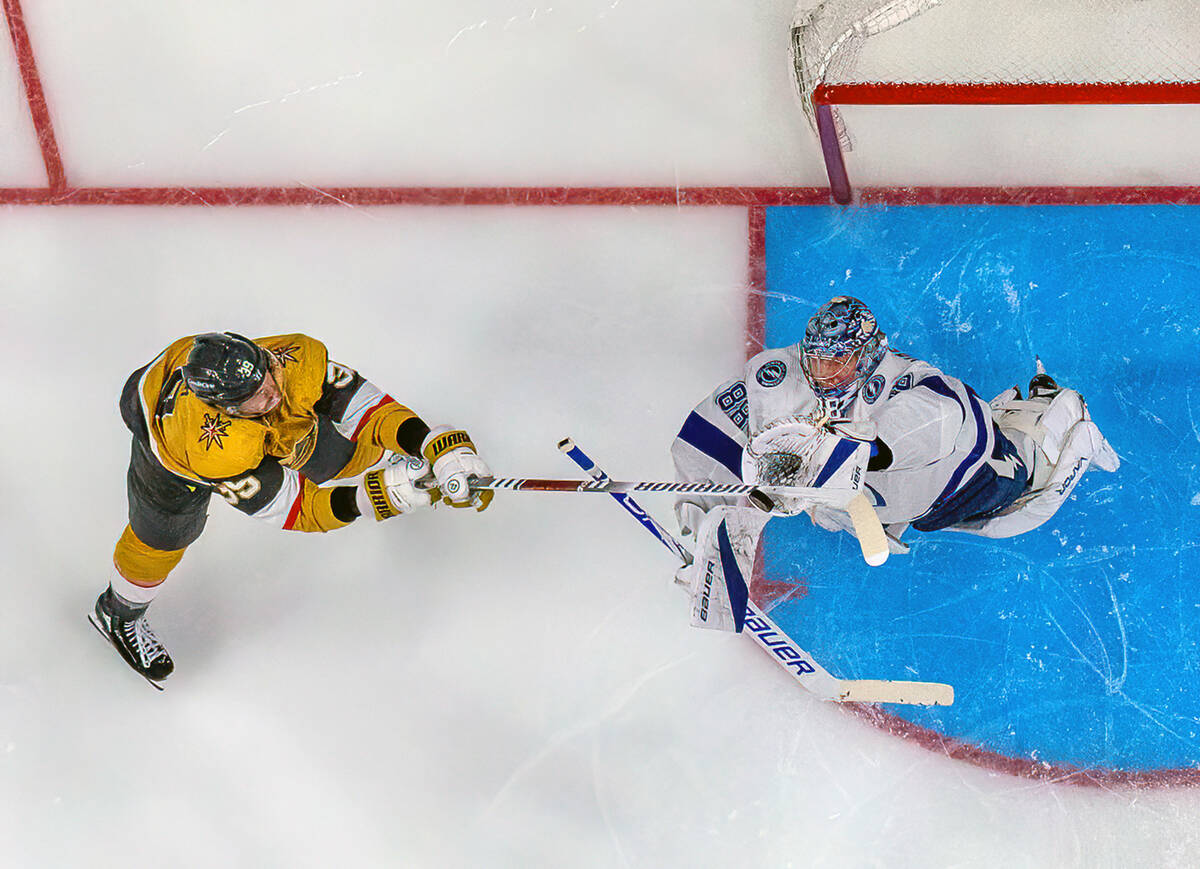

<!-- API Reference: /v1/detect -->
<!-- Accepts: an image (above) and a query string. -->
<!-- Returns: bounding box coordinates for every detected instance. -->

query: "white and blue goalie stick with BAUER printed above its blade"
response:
[558,438,954,706]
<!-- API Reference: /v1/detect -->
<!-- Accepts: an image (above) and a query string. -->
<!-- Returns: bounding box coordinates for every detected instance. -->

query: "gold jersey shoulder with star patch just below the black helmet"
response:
[162,390,265,480]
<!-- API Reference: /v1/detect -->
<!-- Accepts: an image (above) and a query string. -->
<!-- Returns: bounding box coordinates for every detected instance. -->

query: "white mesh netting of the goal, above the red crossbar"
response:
[792,0,1200,144]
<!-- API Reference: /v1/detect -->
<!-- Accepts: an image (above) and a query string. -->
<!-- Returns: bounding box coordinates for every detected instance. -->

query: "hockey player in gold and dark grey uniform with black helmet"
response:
[94,332,492,683]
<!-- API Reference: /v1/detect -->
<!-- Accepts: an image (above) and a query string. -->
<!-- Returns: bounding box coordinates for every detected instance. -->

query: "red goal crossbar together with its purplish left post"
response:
[812,82,1200,205]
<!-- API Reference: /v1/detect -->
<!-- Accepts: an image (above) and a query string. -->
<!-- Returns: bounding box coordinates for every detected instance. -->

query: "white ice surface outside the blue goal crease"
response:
[0,0,1200,869]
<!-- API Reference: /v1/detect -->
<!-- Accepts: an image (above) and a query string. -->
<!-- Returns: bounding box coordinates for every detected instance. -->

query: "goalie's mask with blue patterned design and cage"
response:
[800,295,888,408]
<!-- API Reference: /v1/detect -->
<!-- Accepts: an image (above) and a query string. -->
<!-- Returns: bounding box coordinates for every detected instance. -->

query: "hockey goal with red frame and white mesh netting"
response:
[791,0,1200,203]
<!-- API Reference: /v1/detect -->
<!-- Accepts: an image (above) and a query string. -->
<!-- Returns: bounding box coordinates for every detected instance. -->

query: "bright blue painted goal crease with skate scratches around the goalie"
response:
[764,206,1200,785]
